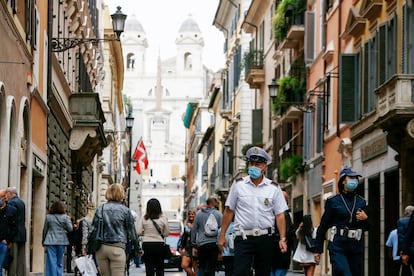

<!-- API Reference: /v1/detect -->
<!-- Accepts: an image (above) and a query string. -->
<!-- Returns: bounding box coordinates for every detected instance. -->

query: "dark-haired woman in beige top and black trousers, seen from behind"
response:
[137,198,170,276]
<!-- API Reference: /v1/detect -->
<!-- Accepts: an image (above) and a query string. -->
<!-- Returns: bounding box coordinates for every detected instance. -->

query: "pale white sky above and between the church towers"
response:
[105,0,224,71]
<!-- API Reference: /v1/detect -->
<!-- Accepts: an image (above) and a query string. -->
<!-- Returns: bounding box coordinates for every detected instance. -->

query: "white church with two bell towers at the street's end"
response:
[121,15,213,219]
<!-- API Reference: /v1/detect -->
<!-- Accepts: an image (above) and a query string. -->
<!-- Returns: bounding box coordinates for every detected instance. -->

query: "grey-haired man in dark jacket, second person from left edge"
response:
[6,187,26,276]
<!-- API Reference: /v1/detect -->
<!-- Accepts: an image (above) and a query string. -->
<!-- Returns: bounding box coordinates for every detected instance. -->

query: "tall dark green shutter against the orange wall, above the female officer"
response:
[339,54,358,123]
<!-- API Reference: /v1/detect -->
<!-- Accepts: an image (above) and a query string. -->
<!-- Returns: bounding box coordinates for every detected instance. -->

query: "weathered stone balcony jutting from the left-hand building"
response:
[69,93,108,165]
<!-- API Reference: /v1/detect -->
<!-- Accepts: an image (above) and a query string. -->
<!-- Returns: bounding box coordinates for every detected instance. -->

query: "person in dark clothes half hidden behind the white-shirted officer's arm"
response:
[270,191,296,276]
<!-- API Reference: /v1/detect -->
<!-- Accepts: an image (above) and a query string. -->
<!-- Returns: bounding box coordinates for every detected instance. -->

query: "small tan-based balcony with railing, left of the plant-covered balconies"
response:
[243,50,265,89]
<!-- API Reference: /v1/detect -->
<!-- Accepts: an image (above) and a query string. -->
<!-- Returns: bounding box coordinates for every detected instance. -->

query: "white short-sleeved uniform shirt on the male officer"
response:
[226,176,288,230]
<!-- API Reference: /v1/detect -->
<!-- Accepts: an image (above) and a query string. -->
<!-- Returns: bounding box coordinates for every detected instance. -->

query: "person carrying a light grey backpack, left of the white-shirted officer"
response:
[191,196,222,276]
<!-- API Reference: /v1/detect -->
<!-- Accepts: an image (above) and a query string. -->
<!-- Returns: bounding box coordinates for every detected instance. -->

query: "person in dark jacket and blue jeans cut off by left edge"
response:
[0,189,17,276]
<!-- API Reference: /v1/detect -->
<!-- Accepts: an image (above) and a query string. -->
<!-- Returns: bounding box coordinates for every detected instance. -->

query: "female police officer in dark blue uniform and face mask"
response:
[315,167,369,276]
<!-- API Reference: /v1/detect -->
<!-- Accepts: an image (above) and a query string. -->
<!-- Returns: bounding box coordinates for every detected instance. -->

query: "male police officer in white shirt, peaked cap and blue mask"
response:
[218,147,288,276]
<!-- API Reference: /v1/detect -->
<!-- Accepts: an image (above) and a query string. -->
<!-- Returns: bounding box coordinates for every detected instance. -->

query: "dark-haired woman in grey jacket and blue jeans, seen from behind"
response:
[42,201,73,276]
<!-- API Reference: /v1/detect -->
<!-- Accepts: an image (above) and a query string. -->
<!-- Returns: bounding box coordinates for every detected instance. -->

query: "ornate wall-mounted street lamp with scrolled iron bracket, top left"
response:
[50,6,127,52]
